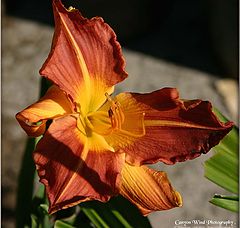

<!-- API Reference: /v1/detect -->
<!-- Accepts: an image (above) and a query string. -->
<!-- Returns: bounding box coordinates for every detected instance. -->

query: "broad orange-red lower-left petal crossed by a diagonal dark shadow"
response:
[34,116,124,213]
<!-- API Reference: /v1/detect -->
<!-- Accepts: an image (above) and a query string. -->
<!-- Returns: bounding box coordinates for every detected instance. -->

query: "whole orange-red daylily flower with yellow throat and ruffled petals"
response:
[16,0,232,215]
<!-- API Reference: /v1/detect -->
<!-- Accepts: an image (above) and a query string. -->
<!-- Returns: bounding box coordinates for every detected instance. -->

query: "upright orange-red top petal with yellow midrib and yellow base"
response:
[40,0,127,112]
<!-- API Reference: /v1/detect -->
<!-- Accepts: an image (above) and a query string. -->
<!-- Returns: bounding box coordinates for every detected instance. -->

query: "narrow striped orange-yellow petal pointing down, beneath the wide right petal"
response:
[120,164,182,215]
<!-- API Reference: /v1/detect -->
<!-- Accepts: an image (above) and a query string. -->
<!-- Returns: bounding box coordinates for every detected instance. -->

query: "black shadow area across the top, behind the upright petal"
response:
[5,0,238,78]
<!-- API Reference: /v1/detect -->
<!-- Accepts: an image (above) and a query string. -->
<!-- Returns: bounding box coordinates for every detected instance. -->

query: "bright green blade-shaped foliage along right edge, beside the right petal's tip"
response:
[204,109,239,212]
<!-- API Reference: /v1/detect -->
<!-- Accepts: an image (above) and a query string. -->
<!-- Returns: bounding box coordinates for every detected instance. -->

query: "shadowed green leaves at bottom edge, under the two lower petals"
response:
[80,196,151,228]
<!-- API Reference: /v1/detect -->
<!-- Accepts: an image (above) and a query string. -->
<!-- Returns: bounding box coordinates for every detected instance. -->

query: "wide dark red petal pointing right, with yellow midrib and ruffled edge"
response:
[106,88,233,165]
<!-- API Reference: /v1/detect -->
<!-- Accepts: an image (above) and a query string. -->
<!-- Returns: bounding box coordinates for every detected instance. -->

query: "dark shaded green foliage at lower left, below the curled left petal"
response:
[16,136,51,228]
